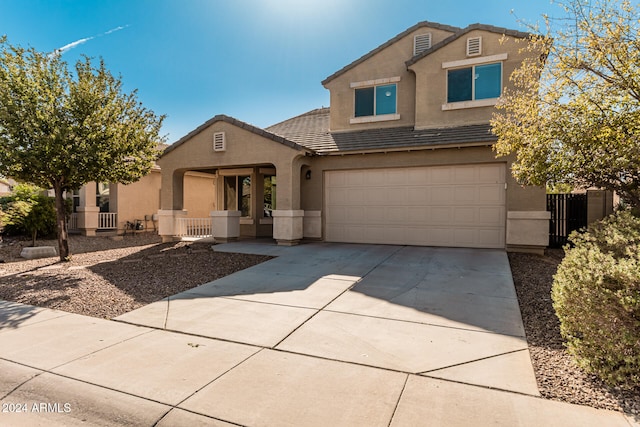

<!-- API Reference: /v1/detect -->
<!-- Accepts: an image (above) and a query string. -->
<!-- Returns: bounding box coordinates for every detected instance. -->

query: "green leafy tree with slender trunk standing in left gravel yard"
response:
[0,37,164,260]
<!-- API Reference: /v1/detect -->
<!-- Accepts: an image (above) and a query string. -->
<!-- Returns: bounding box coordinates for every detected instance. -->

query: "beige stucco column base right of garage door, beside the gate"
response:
[507,211,551,253]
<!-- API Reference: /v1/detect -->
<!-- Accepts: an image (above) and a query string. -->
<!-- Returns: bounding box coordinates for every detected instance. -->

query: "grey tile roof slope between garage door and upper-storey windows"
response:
[267,108,497,155]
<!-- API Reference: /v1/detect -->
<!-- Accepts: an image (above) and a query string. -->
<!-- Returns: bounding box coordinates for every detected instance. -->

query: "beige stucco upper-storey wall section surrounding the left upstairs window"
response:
[325,28,452,131]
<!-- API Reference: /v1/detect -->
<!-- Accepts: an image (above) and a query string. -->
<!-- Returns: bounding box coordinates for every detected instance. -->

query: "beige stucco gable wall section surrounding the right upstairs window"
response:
[410,30,525,128]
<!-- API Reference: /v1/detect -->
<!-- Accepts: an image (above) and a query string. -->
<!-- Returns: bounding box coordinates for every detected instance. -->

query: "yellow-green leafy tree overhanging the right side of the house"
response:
[491,0,640,208]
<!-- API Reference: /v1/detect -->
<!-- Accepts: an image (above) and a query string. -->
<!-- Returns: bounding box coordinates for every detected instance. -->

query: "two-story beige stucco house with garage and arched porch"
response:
[158,22,548,250]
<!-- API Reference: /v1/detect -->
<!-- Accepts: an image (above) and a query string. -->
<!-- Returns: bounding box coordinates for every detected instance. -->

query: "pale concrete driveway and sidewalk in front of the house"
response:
[0,242,631,427]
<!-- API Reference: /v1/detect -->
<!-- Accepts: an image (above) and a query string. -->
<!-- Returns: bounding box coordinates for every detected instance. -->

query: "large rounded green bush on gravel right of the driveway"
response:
[552,211,640,388]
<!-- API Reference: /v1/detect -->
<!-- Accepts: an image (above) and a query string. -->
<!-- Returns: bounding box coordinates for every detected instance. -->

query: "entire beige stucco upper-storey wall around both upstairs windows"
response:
[325,29,525,131]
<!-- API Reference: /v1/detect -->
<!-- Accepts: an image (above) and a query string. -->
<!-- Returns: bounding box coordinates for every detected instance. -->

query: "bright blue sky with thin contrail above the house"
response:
[0,0,561,143]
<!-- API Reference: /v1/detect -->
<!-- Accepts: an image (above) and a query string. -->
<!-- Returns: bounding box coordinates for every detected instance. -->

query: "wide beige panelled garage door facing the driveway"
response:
[325,163,506,248]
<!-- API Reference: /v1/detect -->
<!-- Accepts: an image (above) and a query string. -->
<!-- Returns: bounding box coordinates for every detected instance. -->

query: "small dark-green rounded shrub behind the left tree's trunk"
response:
[0,184,56,246]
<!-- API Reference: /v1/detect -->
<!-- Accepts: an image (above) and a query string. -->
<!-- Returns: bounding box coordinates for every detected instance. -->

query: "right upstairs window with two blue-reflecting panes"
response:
[447,62,502,103]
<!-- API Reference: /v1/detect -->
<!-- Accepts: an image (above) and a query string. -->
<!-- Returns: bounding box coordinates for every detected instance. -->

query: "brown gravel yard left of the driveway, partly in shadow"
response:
[0,233,270,318]
